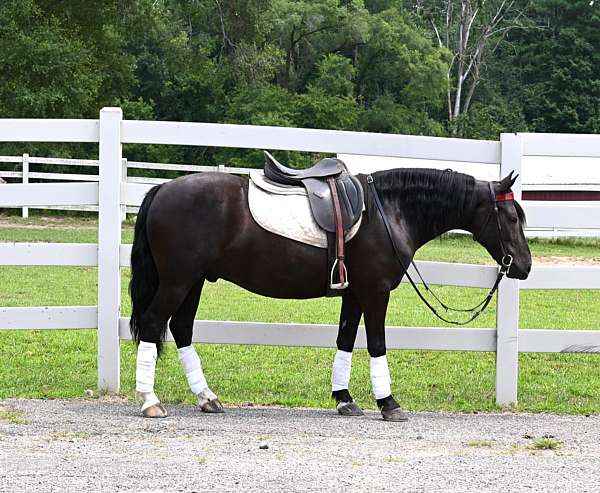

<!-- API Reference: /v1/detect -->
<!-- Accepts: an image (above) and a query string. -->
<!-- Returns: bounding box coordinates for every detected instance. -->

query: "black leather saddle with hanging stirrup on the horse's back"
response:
[264,151,364,295]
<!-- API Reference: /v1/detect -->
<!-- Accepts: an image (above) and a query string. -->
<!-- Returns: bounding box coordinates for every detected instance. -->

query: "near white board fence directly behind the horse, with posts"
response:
[0,108,600,405]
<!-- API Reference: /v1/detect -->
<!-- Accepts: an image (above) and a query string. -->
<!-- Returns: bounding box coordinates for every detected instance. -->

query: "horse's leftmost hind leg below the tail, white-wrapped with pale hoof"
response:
[136,282,189,418]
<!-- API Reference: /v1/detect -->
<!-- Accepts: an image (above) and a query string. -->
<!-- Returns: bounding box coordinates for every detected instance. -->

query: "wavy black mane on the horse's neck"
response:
[373,168,475,233]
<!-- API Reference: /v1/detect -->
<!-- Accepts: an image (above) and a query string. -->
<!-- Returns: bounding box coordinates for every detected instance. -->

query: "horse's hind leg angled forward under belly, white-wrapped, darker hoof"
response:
[169,279,223,413]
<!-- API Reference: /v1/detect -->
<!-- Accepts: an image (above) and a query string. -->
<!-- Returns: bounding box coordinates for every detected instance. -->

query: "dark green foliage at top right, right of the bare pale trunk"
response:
[464,0,600,138]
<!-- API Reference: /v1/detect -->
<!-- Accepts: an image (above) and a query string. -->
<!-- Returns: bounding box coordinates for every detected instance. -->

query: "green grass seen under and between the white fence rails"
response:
[0,213,600,414]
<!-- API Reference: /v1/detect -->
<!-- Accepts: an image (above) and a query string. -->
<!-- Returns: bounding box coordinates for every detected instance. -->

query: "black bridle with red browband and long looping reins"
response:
[367,175,514,325]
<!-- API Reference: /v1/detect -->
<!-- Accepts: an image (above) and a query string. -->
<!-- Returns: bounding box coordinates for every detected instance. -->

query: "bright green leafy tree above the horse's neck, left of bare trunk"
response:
[355,2,450,135]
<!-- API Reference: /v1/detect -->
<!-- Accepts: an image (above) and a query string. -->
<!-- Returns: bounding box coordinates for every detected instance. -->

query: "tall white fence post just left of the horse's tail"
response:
[98,108,123,393]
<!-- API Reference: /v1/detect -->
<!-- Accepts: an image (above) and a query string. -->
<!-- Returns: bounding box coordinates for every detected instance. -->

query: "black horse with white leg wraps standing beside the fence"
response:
[130,169,531,421]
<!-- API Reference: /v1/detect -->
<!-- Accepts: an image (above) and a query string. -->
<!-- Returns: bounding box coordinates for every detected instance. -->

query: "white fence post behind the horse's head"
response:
[496,133,523,406]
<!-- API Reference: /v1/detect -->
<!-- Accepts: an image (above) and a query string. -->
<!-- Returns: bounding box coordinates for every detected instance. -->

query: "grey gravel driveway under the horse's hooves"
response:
[0,399,600,493]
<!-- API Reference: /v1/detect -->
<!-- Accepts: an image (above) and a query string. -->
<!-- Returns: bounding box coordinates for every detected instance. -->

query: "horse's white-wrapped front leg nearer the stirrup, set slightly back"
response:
[331,292,364,416]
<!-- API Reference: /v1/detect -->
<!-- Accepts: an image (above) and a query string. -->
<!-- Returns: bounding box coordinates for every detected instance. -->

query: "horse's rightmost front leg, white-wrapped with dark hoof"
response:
[363,291,408,421]
